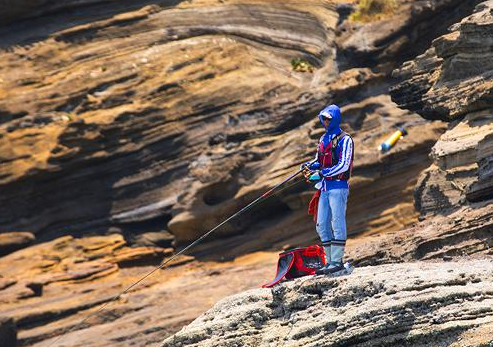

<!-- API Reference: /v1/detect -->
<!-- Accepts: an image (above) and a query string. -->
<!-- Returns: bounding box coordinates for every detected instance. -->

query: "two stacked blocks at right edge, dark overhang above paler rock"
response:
[391,1,493,214]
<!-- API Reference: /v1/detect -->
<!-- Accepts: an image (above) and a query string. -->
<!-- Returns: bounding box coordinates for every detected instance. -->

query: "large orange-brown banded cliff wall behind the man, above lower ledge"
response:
[0,0,453,247]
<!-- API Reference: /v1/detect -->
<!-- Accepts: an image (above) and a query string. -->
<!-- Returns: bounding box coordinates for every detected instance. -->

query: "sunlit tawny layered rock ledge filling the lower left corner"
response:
[0,235,276,347]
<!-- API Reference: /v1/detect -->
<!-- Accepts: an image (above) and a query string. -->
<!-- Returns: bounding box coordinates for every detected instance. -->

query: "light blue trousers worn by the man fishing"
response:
[317,188,349,242]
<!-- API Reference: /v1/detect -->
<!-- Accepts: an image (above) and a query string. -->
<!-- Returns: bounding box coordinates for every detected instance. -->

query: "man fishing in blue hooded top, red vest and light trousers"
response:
[304,105,354,274]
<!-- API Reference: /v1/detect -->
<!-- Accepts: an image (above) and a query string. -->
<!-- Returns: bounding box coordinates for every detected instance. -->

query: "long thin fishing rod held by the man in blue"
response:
[46,161,315,347]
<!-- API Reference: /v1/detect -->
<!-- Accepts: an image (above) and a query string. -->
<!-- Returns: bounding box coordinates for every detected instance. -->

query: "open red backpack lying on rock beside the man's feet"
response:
[262,245,325,288]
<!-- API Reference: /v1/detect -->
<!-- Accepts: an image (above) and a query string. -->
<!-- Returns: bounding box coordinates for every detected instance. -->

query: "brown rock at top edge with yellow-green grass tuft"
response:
[337,0,480,69]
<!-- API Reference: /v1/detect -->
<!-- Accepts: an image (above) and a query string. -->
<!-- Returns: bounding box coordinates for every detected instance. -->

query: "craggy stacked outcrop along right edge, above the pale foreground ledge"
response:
[364,1,493,262]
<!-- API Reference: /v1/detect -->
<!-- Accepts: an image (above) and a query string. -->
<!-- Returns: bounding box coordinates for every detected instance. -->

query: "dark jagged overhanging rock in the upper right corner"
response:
[391,1,493,121]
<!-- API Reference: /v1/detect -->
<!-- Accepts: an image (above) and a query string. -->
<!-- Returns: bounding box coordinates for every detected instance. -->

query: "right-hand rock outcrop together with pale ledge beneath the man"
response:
[162,1,493,347]
